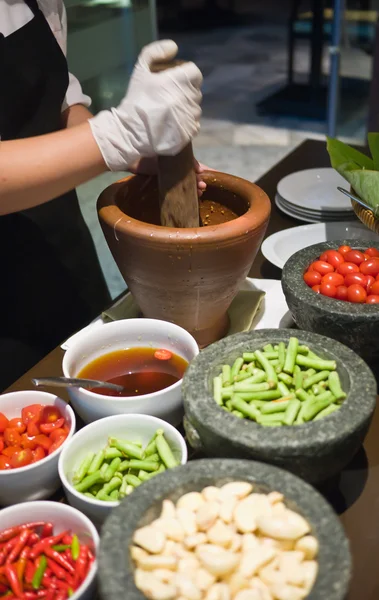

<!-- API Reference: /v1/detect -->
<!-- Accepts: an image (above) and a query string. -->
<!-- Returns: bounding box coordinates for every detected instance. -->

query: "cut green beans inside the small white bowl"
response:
[73,429,179,502]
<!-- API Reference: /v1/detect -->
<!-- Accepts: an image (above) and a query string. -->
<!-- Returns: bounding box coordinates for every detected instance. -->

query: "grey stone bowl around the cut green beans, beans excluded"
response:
[182,329,376,483]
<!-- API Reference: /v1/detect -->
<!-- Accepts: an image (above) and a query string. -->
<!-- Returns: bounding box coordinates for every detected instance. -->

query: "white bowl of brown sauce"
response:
[62,319,199,425]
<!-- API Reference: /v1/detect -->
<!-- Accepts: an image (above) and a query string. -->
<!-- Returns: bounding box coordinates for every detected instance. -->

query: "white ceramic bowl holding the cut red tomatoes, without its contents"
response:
[0,391,76,506]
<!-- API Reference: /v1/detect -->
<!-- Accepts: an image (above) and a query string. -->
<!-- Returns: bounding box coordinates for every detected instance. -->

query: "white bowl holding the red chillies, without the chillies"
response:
[0,502,100,600]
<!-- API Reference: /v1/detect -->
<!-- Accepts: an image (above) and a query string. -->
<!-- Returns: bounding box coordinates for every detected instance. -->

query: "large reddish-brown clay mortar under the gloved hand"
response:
[97,172,271,347]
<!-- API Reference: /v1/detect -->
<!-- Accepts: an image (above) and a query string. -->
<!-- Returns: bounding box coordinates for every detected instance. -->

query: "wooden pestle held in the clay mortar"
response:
[150,61,200,227]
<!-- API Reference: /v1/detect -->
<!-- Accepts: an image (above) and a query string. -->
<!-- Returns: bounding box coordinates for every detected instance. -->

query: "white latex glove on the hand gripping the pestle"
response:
[89,40,202,171]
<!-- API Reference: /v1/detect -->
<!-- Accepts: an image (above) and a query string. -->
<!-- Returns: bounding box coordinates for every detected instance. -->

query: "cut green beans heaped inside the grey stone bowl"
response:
[213,337,346,427]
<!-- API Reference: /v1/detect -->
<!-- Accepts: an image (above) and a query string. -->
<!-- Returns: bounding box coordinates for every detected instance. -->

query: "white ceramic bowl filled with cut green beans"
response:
[58,414,187,525]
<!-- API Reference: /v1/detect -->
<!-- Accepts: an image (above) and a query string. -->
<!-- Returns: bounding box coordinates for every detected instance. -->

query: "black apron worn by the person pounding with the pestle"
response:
[0,0,109,389]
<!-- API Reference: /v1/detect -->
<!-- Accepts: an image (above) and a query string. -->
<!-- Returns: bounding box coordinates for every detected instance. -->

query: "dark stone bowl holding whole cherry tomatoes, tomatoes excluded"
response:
[282,238,379,368]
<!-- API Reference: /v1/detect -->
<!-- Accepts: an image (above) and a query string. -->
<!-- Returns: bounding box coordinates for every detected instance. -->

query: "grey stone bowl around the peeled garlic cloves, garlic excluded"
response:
[99,459,351,600]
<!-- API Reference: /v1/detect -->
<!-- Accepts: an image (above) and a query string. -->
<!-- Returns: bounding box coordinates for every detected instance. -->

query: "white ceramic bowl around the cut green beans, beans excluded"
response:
[58,415,187,525]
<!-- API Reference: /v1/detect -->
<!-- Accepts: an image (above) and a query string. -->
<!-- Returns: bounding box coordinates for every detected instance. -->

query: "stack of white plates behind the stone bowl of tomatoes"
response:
[275,169,354,223]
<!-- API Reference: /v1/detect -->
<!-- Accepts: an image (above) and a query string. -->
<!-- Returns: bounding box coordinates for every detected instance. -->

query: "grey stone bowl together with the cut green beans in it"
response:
[183,329,376,483]
